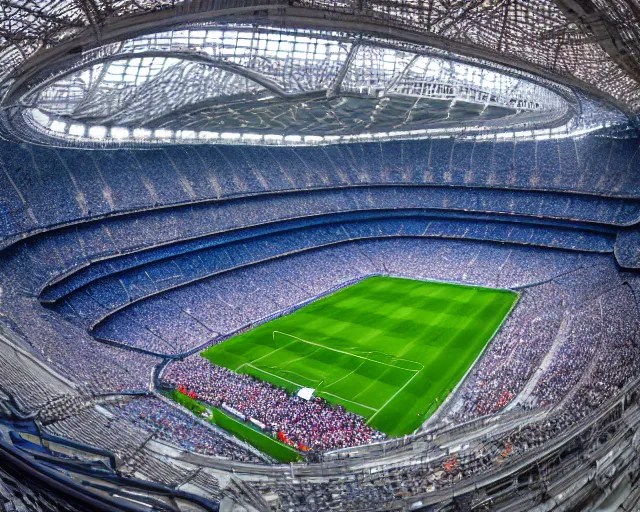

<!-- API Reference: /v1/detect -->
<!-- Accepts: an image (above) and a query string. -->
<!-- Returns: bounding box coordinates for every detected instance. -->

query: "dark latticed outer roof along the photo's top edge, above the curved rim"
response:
[2,0,640,111]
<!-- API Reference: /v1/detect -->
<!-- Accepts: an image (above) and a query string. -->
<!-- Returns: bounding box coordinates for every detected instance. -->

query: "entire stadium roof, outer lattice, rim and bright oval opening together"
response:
[0,0,640,144]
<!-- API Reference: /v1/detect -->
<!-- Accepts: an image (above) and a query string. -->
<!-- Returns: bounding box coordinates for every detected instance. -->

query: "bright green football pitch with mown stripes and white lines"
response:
[203,277,518,436]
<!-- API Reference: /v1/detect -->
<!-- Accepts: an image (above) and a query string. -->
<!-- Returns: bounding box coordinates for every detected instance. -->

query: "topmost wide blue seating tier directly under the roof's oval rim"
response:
[0,137,640,244]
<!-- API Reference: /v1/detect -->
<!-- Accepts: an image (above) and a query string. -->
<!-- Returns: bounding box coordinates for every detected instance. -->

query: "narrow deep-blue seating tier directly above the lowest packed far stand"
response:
[46,217,613,353]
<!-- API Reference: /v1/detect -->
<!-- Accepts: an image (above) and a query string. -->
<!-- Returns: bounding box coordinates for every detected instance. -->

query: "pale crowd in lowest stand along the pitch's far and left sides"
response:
[61,238,604,355]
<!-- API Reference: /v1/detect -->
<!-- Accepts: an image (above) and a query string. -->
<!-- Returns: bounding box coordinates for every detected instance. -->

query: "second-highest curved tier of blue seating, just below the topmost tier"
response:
[0,187,624,293]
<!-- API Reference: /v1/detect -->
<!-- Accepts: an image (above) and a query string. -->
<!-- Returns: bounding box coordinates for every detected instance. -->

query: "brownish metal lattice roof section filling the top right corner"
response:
[296,0,640,112]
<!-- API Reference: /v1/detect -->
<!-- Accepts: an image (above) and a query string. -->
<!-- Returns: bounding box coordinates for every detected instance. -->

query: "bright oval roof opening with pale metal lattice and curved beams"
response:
[23,26,569,139]
